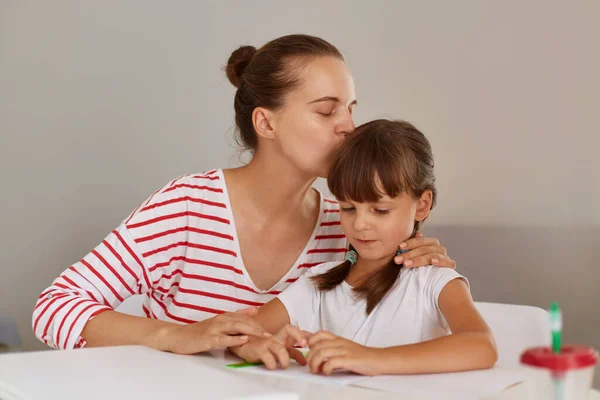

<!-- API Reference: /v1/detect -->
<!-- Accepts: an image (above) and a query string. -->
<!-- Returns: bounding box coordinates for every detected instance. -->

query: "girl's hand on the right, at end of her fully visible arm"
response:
[306,331,382,376]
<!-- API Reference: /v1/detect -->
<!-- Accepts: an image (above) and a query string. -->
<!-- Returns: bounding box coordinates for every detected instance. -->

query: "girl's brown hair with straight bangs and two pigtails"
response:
[311,119,437,314]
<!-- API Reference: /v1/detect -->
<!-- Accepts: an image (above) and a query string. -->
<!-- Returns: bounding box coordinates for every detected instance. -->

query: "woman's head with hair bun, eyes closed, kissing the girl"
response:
[225,35,356,176]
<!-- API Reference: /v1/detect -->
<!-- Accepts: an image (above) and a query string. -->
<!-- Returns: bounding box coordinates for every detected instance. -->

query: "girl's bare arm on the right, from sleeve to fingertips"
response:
[307,279,498,375]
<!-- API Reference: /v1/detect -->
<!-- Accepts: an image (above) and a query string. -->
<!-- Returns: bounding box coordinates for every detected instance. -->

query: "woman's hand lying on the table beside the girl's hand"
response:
[161,307,270,354]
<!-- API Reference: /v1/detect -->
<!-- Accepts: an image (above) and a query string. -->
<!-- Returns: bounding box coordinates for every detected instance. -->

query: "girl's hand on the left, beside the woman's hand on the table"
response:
[229,325,312,370]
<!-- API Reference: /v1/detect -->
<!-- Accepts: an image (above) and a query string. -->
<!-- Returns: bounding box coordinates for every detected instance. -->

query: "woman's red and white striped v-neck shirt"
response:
[33,170,346,349]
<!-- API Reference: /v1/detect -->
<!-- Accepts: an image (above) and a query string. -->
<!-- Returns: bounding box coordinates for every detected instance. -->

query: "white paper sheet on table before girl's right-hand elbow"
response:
[352,367,525,400]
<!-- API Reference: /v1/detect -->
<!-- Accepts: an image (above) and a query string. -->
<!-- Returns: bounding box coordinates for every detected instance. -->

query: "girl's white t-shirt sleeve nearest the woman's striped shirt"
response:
[277,273,321,332]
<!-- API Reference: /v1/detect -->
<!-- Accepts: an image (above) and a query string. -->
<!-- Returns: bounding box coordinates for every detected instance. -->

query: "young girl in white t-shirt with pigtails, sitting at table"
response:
[231,120,497,375]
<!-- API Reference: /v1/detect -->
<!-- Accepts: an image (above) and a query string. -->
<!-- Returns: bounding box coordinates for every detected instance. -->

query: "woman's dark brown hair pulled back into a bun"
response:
[225,35,344,151]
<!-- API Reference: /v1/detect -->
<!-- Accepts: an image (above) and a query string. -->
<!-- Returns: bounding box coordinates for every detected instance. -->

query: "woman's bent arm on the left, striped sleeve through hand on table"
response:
[33,224,265,354]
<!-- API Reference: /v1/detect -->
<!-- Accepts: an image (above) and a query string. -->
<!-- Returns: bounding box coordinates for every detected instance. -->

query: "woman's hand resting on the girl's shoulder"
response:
[394,232,456,269]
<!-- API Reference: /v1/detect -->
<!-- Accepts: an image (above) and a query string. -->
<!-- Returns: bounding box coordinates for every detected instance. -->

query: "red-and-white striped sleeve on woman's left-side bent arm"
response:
[32,224,150,349]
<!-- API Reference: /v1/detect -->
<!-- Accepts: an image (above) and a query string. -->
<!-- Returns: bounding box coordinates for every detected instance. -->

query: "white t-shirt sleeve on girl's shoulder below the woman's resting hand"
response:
[419,266,470,330]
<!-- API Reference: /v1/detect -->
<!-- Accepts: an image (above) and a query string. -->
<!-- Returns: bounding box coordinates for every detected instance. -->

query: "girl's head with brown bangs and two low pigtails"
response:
[312,119,437,313]
